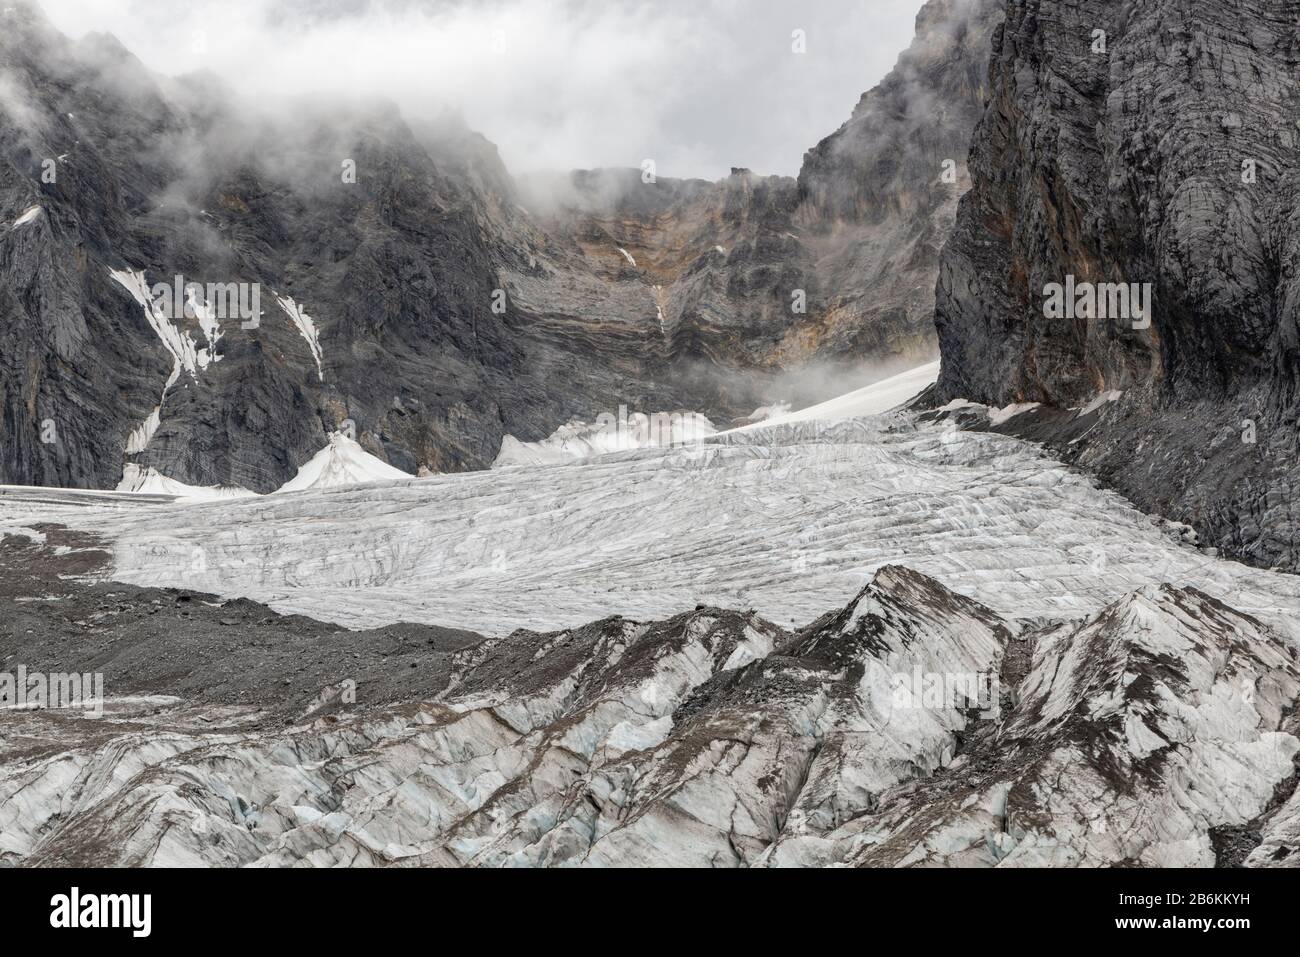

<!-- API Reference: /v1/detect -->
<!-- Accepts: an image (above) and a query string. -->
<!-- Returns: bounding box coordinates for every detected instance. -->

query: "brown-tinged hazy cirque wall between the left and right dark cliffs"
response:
[509,0,1002,403]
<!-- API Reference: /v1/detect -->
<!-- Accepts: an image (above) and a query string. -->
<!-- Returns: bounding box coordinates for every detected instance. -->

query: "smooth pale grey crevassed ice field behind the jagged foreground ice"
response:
[0,371,1300,635]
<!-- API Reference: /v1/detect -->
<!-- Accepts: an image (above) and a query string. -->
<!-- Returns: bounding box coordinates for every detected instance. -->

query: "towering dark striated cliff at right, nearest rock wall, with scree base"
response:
[936,0,1300,568]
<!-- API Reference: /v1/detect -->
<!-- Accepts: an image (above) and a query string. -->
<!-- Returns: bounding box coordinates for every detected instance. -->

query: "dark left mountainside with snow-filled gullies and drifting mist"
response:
[0,7,644,492]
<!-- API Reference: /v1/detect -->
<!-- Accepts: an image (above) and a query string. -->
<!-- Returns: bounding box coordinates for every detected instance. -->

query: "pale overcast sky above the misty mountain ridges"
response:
[42,0,922,179]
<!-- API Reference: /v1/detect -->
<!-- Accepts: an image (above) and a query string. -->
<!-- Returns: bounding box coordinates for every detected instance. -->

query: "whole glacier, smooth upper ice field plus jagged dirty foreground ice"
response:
[0,371,1300,867]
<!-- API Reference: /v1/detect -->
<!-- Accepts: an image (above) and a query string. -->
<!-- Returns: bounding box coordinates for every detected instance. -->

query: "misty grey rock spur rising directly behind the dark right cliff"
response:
[797,0,1004,366]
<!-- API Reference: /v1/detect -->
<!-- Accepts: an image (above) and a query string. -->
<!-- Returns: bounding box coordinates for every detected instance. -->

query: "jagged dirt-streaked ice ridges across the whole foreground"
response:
[0,567,1300,867]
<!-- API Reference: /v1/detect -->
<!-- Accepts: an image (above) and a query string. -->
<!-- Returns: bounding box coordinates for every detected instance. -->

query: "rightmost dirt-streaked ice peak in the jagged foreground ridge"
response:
[771,585,1300,867]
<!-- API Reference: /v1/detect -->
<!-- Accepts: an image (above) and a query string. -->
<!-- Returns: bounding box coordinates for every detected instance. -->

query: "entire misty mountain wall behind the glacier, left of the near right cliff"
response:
[0,0,997,492]
